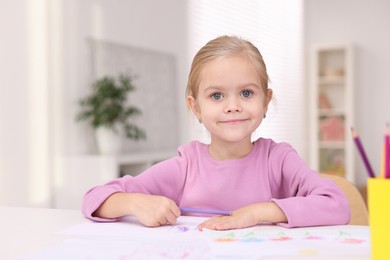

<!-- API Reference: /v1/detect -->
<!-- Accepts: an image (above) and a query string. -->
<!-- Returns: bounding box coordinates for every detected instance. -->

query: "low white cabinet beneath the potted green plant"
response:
[52,150,177,209]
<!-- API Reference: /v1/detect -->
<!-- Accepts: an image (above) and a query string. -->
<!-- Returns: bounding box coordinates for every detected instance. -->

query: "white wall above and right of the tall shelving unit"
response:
[305,0,390,187]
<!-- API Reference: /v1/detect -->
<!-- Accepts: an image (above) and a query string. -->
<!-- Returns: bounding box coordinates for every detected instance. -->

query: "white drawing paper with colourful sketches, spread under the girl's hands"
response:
[25,217,370,260]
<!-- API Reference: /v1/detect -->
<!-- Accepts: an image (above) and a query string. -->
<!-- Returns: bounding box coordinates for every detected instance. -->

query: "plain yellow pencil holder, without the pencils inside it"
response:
[367,178,390,260]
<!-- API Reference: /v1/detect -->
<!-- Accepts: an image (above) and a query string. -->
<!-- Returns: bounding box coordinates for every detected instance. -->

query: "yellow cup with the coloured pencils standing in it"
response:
[352,125,390,260]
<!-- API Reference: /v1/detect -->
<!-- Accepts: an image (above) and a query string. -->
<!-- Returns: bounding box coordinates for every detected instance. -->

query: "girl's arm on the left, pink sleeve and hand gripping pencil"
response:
[82,153,186,226]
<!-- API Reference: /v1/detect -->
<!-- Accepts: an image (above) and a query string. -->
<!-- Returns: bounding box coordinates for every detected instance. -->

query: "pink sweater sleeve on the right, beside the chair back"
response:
[269,142,350,227]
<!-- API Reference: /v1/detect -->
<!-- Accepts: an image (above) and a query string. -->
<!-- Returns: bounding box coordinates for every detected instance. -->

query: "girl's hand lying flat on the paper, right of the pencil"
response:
[198,202,287,231]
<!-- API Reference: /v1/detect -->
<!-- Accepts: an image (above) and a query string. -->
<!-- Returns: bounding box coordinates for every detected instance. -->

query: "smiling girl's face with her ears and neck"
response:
[187,55,272,143]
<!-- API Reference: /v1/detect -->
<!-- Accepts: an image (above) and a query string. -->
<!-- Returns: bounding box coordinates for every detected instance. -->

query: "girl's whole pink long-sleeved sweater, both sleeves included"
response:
[82,138,350,227]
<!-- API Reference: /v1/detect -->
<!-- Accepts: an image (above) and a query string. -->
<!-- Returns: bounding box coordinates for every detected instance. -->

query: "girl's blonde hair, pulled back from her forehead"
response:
[186,36,269,99]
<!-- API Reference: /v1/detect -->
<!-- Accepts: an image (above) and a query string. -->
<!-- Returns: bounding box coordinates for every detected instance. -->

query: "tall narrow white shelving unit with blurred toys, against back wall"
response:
[309,44,355,182]
